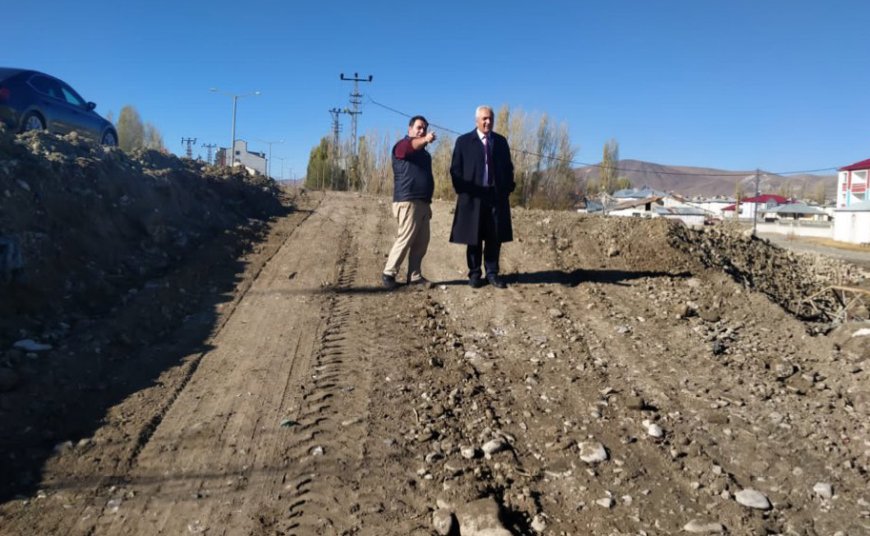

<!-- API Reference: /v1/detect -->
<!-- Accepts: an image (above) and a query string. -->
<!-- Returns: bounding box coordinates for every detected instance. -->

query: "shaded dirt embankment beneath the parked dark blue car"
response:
[0,126,283,348]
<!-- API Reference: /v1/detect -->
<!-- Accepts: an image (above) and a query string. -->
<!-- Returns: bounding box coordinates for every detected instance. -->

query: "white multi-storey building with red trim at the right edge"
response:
[834,159,870,244]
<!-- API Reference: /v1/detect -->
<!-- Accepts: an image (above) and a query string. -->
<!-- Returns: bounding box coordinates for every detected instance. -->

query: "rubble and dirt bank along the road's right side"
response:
[520,212,868,326]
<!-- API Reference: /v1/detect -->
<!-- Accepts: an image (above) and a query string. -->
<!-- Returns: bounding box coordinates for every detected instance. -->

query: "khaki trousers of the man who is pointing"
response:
[384,201,432,281]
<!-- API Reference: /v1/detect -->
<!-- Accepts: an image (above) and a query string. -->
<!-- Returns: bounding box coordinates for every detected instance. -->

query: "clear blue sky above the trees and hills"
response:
[6,0,870,178]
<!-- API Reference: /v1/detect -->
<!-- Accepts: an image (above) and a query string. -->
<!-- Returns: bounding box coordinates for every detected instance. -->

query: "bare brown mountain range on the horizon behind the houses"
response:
[574,160,837,199]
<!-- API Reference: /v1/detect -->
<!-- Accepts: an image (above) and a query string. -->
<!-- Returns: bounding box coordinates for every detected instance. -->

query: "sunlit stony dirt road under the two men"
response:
[0,194,870,536]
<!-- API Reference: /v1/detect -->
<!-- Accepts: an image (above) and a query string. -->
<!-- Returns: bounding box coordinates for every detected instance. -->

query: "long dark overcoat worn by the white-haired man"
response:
[450,129,516,244]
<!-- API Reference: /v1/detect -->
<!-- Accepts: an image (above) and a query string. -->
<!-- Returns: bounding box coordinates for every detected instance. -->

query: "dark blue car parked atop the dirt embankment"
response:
[0,67,118,146]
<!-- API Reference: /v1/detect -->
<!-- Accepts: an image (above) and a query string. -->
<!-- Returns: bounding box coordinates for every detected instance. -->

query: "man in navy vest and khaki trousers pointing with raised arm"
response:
[382,115,435,290]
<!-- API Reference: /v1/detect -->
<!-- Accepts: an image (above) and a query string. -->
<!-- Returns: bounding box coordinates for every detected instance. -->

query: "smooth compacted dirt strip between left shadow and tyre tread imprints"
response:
[61,194,362,534]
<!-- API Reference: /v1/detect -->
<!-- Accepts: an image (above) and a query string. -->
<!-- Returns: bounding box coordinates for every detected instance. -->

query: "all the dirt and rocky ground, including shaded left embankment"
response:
[0,127,870,536]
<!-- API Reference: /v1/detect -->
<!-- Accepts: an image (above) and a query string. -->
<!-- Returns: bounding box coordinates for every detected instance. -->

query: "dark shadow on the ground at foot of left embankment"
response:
[0,207,292,502]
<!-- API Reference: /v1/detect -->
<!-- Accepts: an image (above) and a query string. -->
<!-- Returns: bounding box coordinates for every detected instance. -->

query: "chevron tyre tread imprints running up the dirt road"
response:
[282,223,372,536]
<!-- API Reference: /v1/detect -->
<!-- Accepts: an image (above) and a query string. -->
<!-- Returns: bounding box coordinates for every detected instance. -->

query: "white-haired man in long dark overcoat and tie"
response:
[450,106,516,288]
